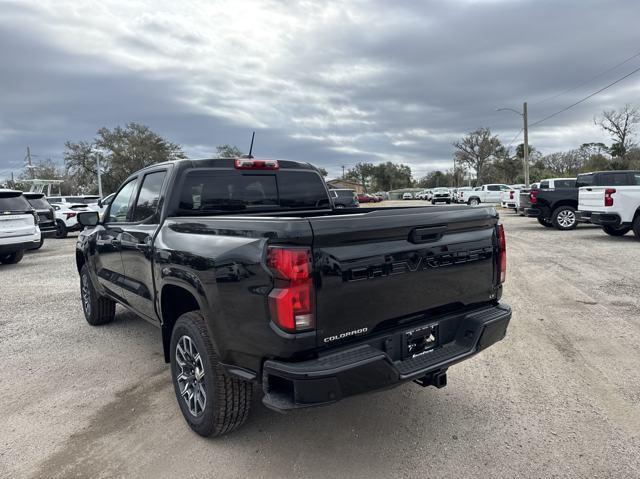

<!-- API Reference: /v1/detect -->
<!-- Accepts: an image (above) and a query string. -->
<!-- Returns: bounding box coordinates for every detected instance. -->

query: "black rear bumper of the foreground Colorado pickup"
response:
[262,305,511,411]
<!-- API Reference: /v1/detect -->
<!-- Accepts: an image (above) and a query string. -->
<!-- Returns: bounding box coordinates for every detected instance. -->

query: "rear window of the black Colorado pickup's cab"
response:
[178,169,329,214]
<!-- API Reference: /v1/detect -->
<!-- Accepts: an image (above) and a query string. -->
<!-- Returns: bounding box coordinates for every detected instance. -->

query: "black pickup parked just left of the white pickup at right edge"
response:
[521,178,578,230]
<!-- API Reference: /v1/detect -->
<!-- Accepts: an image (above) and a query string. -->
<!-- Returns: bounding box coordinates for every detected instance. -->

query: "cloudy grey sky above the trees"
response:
[0,0,640,179]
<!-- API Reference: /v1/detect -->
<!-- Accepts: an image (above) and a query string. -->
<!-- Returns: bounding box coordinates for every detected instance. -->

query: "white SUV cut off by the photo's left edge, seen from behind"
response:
[0,189,41,264]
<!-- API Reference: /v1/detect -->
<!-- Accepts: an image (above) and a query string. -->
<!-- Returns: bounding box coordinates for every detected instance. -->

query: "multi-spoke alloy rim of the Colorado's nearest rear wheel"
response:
[176,335,207,417]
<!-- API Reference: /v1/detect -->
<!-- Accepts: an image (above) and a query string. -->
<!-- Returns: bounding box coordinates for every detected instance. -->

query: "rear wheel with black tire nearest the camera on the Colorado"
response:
[170,311,253,437]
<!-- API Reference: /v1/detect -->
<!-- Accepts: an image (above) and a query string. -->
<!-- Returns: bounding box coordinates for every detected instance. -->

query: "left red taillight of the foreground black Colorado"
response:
[267,246,315,333]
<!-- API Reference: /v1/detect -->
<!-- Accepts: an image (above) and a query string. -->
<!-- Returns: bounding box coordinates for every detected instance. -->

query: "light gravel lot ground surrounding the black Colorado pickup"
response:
[0,201,640,478]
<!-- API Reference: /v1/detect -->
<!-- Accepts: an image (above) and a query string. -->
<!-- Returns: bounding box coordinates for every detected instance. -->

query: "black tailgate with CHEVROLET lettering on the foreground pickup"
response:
[309,206,498,345]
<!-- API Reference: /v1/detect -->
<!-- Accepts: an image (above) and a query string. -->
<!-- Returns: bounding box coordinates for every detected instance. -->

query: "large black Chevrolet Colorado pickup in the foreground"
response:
[76,158,511,436]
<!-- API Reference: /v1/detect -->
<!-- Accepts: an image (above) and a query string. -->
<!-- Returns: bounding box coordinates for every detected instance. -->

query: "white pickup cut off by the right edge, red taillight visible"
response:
[578,171,640,239]
